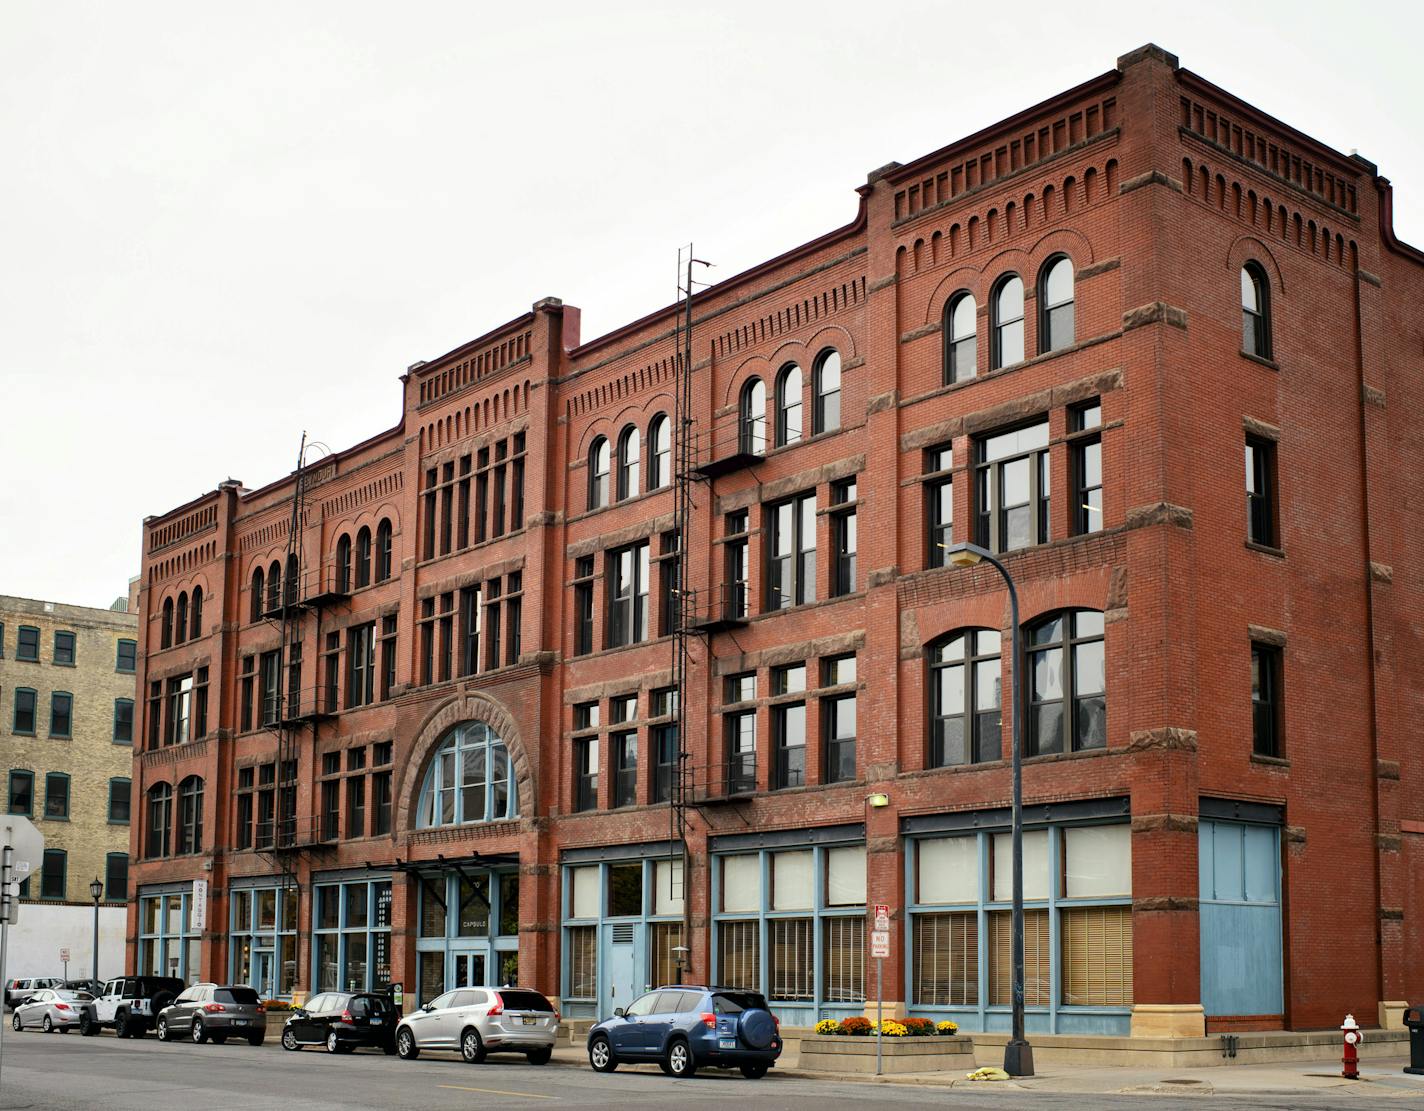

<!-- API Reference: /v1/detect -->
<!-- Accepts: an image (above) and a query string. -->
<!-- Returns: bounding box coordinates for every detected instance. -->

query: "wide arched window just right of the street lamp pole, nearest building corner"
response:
[1024,610,1108,756]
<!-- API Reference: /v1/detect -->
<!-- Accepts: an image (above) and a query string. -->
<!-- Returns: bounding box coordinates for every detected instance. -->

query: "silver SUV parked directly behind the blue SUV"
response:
[396,987,558,1064]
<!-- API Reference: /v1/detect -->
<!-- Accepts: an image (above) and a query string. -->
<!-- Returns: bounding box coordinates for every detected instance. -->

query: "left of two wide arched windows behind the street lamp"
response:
[928,628,1004,768]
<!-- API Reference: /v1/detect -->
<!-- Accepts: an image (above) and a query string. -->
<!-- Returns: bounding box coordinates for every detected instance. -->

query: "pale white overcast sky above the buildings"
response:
[0,0,1424,605]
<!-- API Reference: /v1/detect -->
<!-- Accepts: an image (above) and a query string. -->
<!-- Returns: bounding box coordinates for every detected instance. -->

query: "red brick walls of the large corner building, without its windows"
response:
[131,47,1424,1033]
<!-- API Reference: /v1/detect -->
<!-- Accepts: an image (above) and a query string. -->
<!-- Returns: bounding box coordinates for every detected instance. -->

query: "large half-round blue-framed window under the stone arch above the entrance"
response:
[416,722,518,829]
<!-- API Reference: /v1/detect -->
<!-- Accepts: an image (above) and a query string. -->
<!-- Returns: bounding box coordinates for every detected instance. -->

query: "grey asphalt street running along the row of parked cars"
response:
[0,1030,1412,1111]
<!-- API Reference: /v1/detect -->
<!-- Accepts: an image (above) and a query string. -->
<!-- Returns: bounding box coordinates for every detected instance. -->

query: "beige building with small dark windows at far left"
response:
[0,594,138,905]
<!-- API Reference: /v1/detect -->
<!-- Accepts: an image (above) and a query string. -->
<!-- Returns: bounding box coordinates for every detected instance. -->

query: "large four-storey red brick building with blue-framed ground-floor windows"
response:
[131,47,1424,1033]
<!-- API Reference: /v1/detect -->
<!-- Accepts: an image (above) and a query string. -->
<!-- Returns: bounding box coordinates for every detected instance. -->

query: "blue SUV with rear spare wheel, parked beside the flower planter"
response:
[588,984,782,1080]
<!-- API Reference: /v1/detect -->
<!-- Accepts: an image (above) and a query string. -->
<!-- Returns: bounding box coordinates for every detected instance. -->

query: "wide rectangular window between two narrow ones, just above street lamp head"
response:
[974,420,1049,551]
